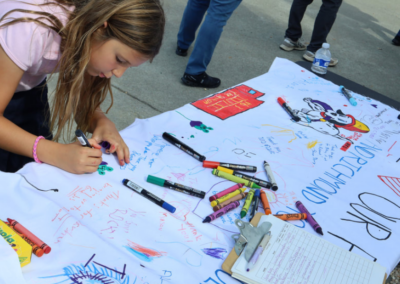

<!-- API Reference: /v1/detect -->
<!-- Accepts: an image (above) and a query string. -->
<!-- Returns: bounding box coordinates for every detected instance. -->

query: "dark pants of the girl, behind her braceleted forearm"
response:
[0,80,53,172]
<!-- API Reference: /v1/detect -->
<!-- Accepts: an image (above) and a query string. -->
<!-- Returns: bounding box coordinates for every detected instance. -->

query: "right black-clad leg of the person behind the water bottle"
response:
[307,0,342,52]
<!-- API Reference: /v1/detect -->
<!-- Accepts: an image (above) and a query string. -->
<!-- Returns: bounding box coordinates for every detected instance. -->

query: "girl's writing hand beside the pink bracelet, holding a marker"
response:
[51,139,103,174]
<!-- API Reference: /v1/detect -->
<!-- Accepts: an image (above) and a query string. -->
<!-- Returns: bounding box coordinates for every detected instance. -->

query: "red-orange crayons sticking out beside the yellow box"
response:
[4,218,51,257]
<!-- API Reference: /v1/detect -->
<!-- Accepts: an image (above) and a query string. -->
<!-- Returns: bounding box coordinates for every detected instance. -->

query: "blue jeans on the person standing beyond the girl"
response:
[178,0,242,75]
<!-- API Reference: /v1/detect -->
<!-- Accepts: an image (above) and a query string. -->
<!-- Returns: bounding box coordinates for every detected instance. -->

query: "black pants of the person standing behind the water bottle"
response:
[285,0,342,52]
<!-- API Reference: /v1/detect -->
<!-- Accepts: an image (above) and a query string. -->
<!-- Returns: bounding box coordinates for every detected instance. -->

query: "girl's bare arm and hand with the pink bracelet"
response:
[0,45,101,173]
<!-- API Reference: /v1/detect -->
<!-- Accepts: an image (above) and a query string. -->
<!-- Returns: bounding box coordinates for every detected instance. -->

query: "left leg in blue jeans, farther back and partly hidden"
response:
[178,0,210,52]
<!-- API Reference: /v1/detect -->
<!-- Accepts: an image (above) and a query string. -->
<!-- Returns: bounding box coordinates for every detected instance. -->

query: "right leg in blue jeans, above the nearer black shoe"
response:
[185,0,242,75]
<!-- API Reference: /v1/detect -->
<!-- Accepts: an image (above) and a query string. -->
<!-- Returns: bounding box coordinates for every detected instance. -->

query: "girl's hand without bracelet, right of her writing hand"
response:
[92,118,130,166]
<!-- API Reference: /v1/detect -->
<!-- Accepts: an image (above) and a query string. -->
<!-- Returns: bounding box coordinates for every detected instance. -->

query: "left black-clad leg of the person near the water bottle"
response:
[285,0,313,41]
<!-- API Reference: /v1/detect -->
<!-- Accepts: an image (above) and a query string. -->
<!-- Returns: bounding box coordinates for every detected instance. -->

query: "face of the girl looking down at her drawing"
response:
[86,39,149,78]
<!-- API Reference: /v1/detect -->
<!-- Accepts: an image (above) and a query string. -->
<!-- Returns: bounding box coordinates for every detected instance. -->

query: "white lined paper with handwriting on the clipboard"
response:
[232,215,386,284]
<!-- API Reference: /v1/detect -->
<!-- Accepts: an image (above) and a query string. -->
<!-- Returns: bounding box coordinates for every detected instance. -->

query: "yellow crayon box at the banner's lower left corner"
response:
[0,220,32,267]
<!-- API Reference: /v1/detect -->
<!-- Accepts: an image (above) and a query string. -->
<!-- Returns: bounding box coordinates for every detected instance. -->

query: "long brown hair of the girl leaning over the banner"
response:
[0,0,165,140]
